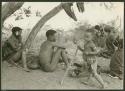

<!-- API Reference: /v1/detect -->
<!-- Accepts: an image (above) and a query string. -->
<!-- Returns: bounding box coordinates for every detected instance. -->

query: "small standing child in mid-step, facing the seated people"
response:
[78,30,105,88]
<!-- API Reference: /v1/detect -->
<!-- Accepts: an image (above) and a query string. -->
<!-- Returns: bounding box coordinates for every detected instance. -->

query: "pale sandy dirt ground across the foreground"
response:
[1,56,123,90]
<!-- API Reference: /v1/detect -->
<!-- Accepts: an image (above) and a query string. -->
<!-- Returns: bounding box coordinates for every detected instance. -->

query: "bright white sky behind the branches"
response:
[2,2,124,30]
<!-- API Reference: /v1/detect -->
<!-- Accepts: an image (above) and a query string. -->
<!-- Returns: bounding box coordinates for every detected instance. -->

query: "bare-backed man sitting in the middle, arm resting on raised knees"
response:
[39,30,68,72]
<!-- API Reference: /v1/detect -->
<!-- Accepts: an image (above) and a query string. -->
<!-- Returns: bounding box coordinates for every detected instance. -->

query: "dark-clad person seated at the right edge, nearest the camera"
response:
[110,39,124,79]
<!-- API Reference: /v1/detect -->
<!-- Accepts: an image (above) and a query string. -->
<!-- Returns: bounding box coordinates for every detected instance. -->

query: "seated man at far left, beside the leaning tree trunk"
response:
[2,27,22,65]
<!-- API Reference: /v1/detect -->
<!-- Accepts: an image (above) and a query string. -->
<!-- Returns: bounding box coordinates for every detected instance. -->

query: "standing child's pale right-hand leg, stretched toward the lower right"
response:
[91,61,105,88]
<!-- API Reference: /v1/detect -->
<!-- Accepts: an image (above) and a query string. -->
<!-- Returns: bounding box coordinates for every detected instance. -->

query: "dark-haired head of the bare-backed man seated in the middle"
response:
[46,29,56,42]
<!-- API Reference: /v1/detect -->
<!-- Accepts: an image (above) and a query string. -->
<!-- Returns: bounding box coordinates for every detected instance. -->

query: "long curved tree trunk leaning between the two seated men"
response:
[23,4,63,50]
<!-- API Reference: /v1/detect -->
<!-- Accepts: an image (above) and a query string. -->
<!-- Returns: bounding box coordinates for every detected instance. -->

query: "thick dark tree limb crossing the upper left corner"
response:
[1,2,24,26]
